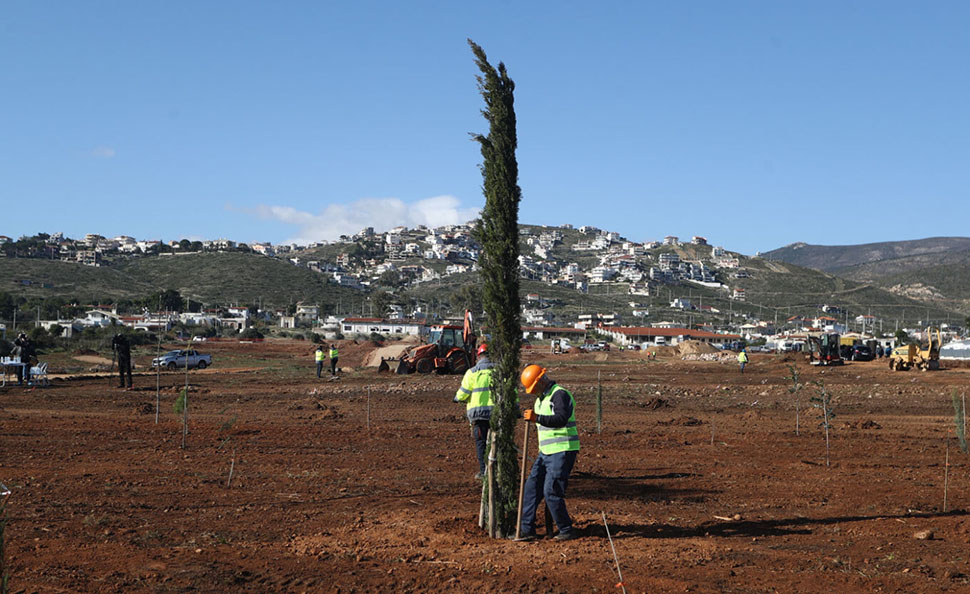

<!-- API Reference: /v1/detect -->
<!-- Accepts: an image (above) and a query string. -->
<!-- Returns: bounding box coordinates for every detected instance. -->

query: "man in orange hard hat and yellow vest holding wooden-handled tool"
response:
[519,365,579,541]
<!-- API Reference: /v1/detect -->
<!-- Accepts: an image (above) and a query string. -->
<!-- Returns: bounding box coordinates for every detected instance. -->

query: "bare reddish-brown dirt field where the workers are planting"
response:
[0,341,970,592]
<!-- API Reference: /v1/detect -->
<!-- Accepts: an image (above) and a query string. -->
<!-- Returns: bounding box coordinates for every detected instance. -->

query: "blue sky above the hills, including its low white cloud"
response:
[0,0,970,254]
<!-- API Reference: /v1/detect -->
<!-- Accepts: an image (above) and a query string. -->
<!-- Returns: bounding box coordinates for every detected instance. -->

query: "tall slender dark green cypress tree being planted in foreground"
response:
[468,39,522,536]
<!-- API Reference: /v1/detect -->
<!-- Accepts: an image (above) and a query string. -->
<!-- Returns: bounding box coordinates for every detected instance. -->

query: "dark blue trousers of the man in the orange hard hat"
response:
[520,451,578,536]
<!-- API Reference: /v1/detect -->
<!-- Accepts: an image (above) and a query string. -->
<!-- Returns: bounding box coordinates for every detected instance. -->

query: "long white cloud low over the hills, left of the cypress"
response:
[246,196,479,244]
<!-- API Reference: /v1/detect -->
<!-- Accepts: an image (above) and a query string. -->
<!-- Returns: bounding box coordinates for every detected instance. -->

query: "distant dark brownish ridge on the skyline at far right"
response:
[761,237,970,273]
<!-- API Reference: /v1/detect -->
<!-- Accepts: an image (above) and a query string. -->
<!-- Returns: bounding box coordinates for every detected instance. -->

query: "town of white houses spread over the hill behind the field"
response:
[0,223,959,347]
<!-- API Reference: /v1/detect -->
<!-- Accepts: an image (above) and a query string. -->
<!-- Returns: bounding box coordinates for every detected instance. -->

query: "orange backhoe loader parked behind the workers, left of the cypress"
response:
[377,311,476,375]
